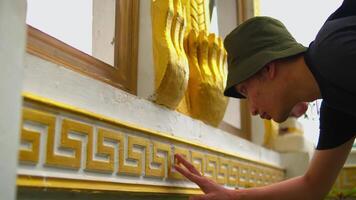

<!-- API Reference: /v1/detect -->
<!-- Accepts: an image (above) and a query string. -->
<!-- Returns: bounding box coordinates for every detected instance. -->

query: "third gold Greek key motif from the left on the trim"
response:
[85,128,123,173]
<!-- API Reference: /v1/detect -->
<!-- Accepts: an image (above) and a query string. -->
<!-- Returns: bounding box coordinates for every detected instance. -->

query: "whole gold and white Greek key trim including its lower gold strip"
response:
[18,93,285,194]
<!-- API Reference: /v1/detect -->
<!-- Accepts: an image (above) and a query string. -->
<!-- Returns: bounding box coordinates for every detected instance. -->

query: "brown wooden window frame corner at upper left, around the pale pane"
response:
[26,0,139,95]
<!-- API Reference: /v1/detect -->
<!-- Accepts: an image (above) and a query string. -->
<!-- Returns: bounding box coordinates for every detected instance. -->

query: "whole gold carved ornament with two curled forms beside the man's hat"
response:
[152,0,228,126]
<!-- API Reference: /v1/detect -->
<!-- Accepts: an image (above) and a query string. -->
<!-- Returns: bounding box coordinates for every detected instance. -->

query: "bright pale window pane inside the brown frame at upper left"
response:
[26,0,115,65]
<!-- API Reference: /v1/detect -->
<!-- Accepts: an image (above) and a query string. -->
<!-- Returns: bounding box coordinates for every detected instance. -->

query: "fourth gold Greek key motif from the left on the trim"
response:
[119,136,149,176]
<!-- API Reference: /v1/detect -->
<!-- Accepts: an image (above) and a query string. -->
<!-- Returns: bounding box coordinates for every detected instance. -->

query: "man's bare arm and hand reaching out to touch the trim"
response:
[175,138,355,200]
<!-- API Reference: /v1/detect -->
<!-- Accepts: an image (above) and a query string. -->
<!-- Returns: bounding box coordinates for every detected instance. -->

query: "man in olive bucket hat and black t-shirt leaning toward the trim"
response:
[175,0,356,200]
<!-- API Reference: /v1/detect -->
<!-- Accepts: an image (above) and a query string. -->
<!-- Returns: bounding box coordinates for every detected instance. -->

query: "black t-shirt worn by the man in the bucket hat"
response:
[305,0,356,150]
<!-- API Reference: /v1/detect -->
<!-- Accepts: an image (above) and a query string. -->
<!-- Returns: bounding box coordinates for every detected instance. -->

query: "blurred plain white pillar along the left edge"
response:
[0,0,26,200]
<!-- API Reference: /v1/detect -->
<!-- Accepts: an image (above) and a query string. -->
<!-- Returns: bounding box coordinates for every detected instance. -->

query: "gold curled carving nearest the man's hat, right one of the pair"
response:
[181,30,228,126]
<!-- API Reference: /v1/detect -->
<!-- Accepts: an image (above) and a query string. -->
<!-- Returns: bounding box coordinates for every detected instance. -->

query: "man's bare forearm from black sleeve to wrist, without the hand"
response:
[241,138,354,200]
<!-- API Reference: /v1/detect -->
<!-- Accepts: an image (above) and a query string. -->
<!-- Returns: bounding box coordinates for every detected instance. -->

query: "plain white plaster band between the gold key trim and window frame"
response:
[24,55,280,166]
